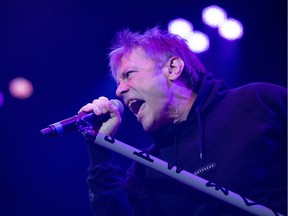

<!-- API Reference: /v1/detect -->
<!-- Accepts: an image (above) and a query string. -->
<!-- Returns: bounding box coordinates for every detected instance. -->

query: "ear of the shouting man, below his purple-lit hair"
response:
[166,56,184,81]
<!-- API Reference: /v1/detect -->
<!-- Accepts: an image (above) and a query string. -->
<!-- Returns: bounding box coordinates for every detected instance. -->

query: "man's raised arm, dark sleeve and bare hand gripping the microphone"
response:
[79,97,132,216]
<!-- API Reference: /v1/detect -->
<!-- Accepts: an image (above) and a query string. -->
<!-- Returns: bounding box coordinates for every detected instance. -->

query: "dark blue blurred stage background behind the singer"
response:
[0,0,287,216]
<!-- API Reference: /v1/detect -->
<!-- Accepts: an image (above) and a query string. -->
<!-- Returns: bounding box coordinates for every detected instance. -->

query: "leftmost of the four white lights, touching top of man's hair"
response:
[168,18,193,39]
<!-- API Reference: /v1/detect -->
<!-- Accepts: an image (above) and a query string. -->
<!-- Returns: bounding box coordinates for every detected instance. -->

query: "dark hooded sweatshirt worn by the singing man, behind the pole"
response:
[88,75,287,216]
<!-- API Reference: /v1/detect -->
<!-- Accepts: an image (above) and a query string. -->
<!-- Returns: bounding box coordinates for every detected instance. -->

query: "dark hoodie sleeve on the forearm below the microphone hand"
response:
[87,141,132,216]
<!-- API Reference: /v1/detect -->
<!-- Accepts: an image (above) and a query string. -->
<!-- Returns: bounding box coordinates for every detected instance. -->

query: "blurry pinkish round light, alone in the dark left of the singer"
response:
[9,77,33,99]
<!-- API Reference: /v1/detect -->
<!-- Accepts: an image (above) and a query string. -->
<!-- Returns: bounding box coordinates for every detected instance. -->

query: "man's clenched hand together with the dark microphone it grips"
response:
[41,97,124,136]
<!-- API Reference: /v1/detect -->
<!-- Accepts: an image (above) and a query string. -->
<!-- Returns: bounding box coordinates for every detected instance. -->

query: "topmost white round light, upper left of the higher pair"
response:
[202,5,227,27]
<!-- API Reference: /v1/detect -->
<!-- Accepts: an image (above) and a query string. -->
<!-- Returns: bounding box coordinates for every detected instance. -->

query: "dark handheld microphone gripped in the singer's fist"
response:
[40,99,124,137]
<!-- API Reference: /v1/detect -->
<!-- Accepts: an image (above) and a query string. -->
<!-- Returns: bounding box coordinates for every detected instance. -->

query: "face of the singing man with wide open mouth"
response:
[116,48,171,132]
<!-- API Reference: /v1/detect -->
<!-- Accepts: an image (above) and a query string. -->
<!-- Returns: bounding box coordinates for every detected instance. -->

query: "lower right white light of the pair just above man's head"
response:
[187,31,209,53]
